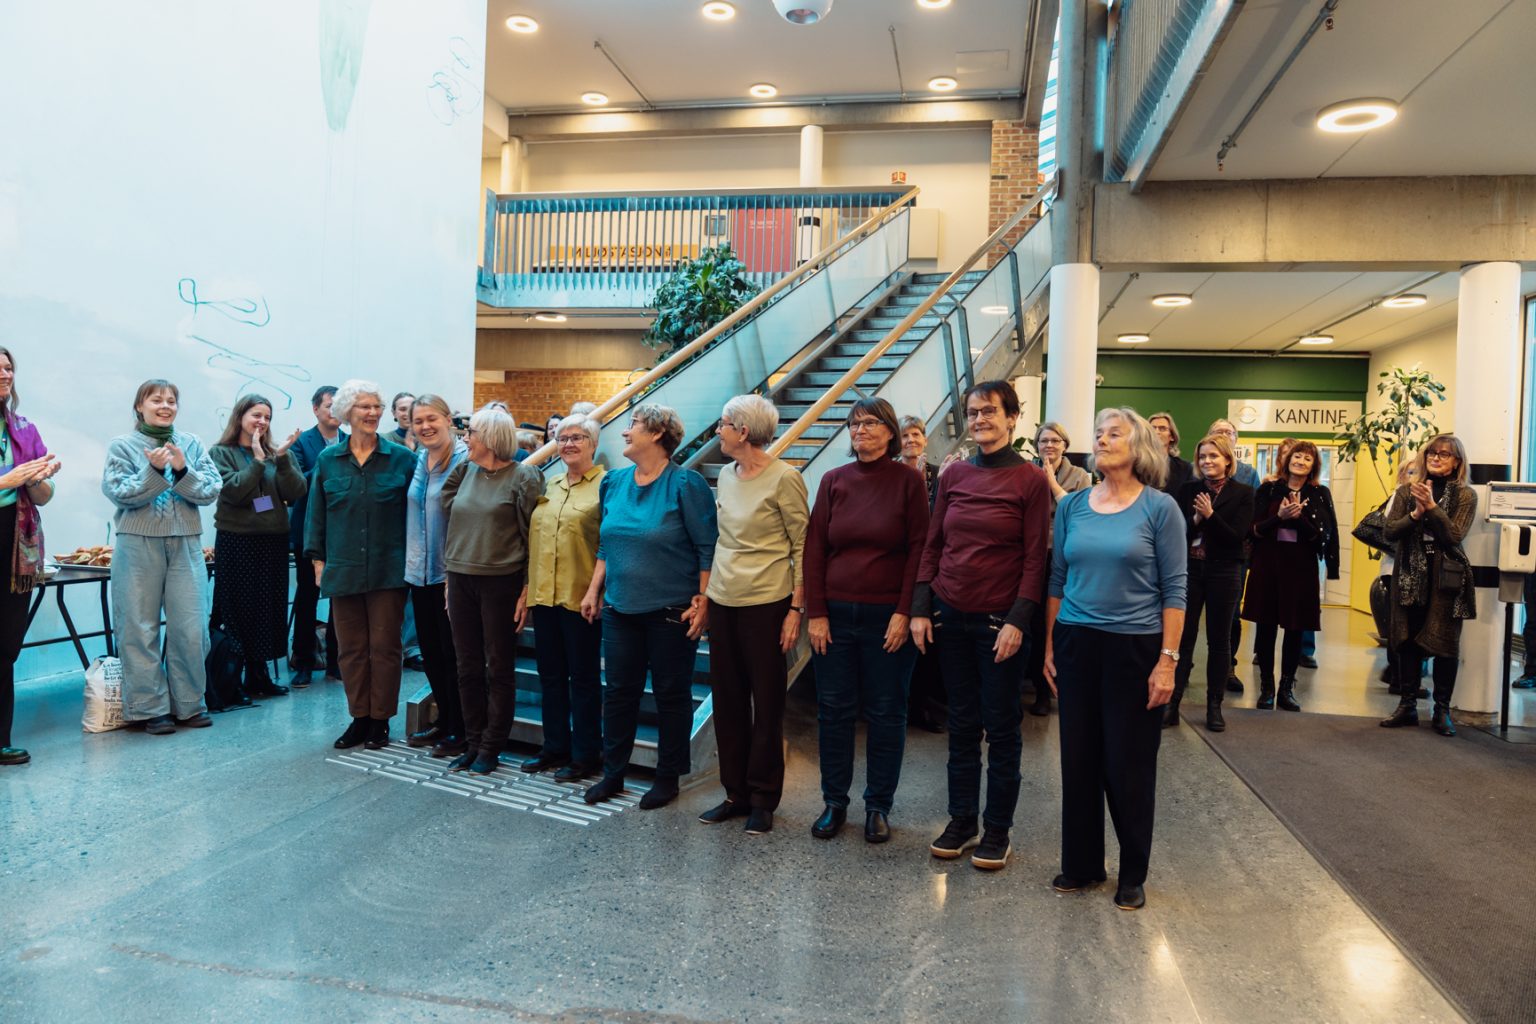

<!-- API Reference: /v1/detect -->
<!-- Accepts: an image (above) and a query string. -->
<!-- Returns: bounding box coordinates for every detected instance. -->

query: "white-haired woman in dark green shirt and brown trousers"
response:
[304,381,416,751]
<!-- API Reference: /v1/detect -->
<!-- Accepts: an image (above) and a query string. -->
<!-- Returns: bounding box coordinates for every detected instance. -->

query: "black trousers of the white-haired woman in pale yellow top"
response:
[710,597,790,811]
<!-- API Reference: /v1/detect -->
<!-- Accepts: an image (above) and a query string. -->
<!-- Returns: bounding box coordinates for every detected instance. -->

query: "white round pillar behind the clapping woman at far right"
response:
[1450,263,1522,714]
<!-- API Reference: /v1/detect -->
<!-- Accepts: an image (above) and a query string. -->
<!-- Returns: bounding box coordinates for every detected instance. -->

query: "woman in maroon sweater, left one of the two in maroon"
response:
[805,398,928,843]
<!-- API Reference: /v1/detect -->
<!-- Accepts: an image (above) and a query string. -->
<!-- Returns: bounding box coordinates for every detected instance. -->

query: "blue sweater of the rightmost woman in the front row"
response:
[1049,487,1189,634]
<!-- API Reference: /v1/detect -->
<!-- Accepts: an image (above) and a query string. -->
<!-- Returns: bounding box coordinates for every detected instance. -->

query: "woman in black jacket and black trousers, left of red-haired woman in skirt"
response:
[1163,434,1253,732]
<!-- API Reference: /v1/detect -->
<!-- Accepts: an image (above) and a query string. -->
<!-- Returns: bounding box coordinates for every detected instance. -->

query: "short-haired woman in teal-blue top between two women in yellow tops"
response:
[581,405,717,809]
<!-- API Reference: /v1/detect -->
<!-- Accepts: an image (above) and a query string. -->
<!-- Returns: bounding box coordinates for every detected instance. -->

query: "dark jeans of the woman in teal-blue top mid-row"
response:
[602,606,699,778]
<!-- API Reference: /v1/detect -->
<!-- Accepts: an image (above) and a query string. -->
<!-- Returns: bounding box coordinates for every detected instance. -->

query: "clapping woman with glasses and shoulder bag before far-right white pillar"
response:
[1381,434,1478,735]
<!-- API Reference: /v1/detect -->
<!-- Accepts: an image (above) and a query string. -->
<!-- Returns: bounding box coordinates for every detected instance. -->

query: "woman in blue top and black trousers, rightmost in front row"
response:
[1044,408,1187,910]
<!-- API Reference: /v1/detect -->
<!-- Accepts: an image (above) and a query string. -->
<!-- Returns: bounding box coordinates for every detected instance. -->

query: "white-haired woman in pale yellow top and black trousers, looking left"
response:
[699,395,811,835]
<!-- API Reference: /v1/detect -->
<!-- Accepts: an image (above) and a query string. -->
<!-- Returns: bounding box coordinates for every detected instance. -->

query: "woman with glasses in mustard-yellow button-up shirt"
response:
[518,415,605,781]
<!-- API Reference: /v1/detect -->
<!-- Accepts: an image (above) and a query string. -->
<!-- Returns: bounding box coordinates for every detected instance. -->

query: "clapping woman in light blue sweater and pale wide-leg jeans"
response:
[101,381,224,735]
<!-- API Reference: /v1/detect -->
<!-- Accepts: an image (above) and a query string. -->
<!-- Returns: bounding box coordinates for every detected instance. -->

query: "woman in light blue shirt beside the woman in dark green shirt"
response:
[406,395,470,757]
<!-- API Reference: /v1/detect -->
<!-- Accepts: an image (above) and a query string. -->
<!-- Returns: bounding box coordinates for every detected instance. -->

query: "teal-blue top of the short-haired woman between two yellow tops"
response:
[598,462,719,616]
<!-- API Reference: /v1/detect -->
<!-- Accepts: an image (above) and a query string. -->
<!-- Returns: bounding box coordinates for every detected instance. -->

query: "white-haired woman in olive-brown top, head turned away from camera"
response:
[442,405,544,775]
